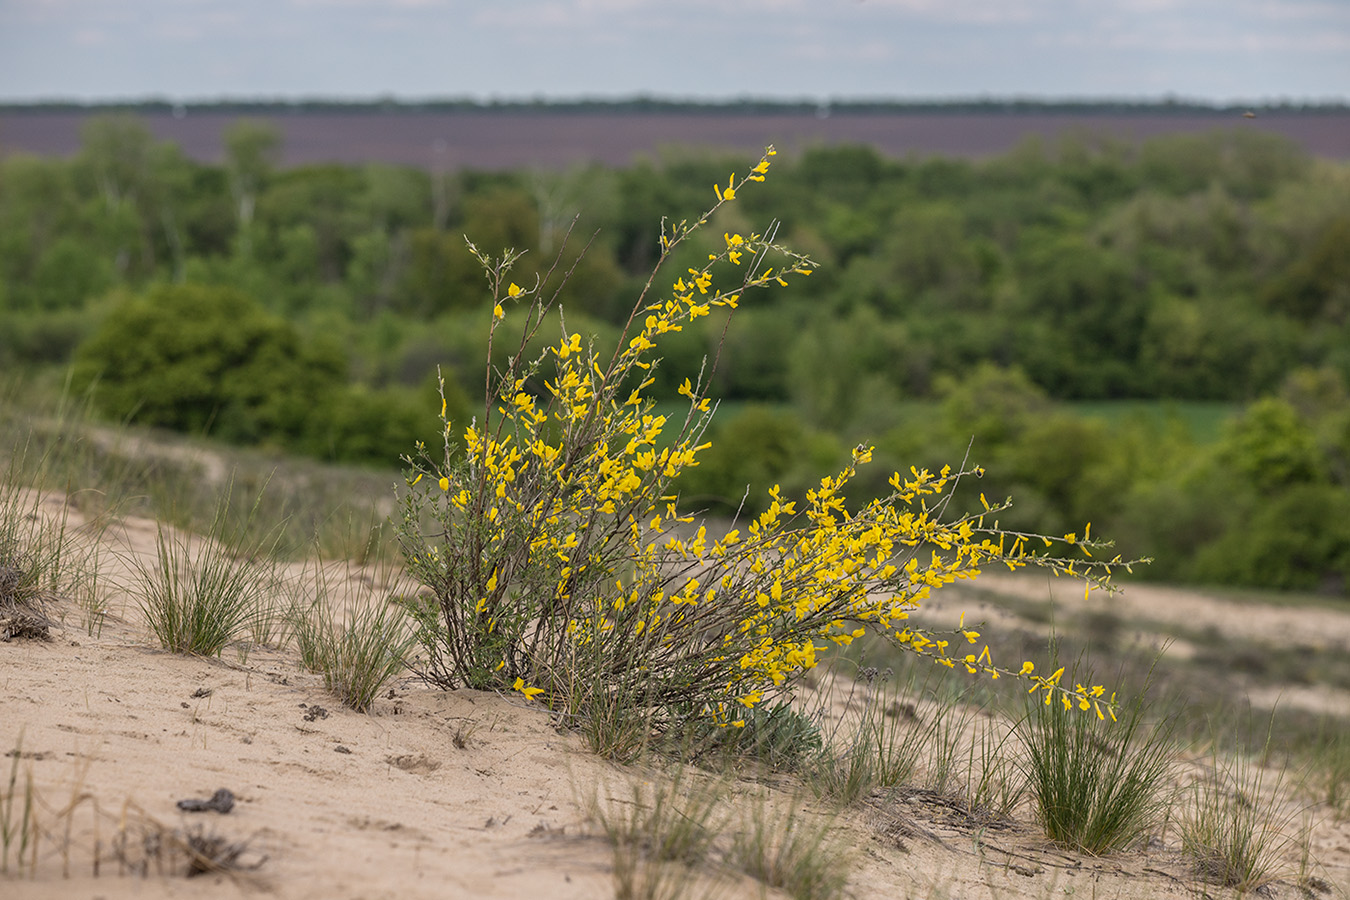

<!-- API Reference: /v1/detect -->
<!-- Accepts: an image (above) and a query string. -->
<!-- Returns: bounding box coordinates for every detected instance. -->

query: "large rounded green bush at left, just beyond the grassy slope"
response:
[74,285,442,466]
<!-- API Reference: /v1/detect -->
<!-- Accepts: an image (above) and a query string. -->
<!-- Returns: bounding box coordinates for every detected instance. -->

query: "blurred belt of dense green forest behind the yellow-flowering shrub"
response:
[0,116,1350,594]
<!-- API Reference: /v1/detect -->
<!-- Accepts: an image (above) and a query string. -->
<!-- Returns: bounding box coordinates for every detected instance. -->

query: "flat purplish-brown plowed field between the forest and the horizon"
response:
[0,111,1350,170]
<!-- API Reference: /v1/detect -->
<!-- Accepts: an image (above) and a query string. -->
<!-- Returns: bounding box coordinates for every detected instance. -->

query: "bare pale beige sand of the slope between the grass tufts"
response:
[0,501,1350,900]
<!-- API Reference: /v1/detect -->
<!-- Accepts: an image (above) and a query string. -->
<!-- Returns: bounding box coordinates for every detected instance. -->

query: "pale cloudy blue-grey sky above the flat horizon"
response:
[0,0,1350,104]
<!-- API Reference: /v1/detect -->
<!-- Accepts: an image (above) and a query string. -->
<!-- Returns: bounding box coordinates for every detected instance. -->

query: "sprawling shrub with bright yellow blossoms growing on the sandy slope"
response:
[398,147,1125,722]
